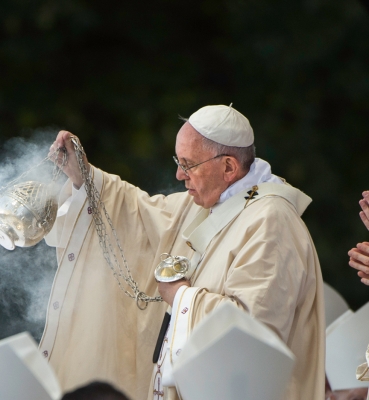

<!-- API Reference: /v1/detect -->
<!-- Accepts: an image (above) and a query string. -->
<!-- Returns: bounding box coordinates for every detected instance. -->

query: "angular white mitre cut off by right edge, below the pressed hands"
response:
[326,302,369,390]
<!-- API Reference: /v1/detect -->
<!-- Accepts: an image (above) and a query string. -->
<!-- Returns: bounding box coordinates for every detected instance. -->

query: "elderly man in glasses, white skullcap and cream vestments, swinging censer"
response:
[40,106,325,400]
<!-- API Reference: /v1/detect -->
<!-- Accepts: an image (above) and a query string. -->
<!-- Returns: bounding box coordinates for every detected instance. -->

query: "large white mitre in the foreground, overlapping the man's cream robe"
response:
[173,302,295,400]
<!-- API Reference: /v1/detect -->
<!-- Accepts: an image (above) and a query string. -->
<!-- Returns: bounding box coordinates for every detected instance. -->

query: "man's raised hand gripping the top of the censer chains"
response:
[49,131,90,189]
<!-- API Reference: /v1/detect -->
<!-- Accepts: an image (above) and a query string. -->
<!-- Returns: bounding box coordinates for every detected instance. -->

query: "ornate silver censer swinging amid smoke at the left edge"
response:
[0,181,58,250]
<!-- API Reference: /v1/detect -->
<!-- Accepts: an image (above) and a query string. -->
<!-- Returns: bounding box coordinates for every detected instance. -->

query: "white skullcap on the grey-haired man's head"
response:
[188,104,254,147]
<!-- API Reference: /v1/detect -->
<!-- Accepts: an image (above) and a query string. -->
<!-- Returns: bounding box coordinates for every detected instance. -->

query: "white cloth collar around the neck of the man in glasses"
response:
[210,158,283,213]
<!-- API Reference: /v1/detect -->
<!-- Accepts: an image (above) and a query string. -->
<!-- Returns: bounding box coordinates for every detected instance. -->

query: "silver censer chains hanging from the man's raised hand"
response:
[72,136,163,310]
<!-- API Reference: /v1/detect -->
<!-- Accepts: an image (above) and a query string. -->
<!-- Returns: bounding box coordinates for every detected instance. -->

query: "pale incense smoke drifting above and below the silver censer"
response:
[0,129,63,341]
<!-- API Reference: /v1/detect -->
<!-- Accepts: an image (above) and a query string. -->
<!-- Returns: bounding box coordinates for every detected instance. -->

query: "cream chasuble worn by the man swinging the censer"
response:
[41,168,325,400]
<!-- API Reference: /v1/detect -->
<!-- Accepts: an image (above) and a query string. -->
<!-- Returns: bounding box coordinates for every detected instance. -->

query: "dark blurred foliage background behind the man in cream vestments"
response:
[0,0,369,338]
